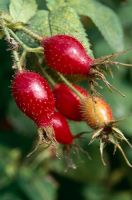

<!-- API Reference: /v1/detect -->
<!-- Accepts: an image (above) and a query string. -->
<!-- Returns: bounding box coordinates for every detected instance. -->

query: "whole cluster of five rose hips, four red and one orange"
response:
[11,35,132,166]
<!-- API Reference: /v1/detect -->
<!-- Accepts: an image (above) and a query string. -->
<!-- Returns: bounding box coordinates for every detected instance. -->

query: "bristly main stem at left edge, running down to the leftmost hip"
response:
[1,18,22,71]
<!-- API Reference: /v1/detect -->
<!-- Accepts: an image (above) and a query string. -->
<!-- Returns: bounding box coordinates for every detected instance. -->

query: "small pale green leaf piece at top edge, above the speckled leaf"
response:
[46,0,65,10]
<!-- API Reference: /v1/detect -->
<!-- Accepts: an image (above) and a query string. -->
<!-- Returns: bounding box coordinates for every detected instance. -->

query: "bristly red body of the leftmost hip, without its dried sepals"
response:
[11,70,55,127]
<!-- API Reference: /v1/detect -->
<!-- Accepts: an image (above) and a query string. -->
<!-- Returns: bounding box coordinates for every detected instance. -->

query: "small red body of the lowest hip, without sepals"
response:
[52,112,74,144]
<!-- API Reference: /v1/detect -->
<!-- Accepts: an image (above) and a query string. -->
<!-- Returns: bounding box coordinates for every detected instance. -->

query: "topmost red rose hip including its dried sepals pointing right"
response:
[41,35,131,96]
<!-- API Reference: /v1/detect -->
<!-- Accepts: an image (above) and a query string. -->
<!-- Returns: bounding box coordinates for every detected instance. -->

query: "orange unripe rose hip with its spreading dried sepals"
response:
[81,96,132,167]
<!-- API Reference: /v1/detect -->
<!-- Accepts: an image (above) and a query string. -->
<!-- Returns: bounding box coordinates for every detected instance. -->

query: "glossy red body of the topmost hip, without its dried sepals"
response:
[42,35,93,75]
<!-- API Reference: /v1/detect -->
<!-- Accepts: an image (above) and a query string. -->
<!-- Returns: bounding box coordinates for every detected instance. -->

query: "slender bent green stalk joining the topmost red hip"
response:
[8,28,43,53]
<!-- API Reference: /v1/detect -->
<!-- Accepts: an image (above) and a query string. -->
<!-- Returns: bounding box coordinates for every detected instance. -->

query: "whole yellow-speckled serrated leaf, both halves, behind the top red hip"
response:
[18,7,93,56]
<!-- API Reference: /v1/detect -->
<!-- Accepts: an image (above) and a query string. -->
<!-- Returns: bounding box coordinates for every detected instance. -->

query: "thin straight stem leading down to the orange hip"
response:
[57,72,84,99]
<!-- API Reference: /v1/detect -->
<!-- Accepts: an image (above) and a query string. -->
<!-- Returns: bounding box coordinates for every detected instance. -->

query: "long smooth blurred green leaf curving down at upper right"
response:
[68,0,124,51]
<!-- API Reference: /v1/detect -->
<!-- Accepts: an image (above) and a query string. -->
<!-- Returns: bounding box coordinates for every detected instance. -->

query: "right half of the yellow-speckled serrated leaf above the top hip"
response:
[49,6,93,56]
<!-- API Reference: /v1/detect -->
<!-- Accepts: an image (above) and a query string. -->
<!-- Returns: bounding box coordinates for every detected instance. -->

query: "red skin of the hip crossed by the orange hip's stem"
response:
[53,83,89,121]
